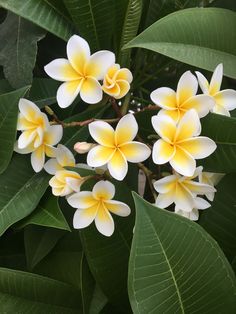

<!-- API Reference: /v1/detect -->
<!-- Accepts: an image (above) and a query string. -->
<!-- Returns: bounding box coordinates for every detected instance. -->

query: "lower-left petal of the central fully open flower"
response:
[87,145,115,167]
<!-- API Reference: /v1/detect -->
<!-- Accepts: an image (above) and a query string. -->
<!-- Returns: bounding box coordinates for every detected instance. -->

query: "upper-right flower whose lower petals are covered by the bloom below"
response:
[151,71,214,122]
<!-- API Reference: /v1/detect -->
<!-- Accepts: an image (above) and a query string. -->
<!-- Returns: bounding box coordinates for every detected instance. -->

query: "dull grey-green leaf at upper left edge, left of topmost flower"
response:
[0,12,45,88]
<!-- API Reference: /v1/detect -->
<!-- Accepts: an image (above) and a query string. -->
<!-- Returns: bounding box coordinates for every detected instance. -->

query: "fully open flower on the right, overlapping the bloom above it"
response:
[152,109,216,176]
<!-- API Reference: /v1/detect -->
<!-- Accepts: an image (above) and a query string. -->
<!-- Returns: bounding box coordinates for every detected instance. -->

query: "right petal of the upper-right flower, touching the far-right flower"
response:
[181,95,215,118]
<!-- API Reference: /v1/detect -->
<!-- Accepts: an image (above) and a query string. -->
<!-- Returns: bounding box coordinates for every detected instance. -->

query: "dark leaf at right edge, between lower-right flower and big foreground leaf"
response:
[199,174,236,259]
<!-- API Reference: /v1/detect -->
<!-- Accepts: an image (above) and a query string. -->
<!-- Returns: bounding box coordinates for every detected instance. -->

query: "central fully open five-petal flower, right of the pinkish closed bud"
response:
[87,114,151,180]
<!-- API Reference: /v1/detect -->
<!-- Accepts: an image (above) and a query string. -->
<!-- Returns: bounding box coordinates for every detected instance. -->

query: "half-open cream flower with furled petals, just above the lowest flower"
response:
[49,170,86,196]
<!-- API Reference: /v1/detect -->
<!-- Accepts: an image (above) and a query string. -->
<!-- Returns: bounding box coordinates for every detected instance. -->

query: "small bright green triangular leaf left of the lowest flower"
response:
[17,189,70,231]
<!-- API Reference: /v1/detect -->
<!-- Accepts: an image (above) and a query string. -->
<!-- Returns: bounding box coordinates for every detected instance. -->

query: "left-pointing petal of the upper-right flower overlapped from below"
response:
[150,87,177,110]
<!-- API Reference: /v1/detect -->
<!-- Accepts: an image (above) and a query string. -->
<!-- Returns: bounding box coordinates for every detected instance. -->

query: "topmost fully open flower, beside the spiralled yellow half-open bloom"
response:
[44,35,115,108]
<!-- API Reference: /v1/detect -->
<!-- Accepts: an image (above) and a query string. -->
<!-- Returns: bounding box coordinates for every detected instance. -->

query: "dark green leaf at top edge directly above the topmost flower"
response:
[63,0,114,51]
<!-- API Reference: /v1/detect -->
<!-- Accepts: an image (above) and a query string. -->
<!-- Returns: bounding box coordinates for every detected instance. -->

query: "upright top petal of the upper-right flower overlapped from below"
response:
[176,71,198,105]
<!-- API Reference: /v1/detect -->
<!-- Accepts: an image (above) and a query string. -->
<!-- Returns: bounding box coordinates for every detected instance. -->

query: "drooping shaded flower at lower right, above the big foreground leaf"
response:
[153,167,216,212]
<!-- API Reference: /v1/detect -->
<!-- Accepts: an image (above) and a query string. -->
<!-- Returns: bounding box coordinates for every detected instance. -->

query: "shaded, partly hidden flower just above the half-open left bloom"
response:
[44,144,75,174]
